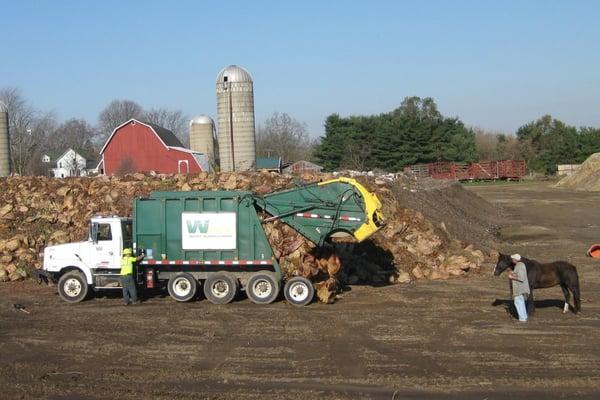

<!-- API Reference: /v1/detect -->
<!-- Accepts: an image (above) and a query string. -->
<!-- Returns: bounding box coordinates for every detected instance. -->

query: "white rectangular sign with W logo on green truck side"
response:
[181,212,236,250]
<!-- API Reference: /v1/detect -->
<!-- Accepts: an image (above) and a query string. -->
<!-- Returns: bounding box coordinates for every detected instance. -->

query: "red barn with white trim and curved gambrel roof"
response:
[99,119,208,175]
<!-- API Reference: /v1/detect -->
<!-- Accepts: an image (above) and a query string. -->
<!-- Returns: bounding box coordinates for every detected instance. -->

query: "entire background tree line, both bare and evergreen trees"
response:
[0,88,600,175]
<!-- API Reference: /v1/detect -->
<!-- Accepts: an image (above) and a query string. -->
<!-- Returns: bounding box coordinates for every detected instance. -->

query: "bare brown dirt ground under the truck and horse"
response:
[0,183,600,399]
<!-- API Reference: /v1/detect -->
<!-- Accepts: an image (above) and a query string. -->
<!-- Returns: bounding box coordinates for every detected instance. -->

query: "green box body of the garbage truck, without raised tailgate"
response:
[133,191,281,277]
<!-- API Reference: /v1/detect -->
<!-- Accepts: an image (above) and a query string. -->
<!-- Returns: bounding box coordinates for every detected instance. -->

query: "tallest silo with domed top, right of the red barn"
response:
[217,65,256,171]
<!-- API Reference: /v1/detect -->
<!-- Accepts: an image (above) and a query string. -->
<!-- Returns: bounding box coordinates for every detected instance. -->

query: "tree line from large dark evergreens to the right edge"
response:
[314,97,600,174]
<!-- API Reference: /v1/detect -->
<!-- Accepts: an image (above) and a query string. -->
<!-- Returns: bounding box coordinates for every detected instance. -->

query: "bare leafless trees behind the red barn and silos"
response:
[0,87,316,175]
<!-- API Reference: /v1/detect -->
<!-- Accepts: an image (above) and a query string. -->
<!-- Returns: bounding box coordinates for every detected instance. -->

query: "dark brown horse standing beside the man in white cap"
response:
[494,253,581,314]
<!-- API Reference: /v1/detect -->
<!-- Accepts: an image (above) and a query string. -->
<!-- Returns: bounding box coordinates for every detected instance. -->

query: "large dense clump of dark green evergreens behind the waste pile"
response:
[315,97,477,171]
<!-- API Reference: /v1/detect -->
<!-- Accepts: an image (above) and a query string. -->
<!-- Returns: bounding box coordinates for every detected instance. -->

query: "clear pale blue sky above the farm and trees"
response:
[0,0,600,135]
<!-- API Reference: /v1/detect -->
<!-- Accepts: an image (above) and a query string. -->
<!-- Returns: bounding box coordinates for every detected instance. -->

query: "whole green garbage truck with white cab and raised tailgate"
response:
[40,178,384,305]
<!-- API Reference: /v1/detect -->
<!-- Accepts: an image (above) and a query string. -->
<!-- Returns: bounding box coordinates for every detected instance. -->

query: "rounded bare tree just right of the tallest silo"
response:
[256,112,312,162]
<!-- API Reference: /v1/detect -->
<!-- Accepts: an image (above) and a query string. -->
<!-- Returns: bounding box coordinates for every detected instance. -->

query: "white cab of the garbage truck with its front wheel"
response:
[38,216,132,303]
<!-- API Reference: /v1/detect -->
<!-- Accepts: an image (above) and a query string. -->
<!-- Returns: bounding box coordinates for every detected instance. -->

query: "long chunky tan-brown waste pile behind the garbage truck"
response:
[0,172,486,302]
